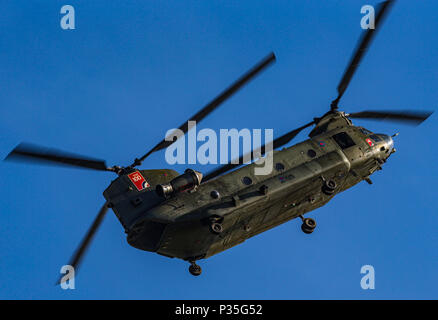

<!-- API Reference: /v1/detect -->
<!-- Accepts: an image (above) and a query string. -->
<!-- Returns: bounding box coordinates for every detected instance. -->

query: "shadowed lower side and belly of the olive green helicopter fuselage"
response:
[128,170,361,260]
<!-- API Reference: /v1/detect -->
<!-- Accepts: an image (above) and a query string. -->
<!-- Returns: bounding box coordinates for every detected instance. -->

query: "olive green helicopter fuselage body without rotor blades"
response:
[104,113,392,260]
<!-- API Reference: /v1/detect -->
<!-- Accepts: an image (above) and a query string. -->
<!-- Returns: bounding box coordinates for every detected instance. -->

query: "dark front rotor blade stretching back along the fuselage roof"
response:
[202,121,315,182]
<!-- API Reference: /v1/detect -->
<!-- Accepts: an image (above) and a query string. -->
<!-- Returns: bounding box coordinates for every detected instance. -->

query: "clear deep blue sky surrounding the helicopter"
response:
[0,0,438,299]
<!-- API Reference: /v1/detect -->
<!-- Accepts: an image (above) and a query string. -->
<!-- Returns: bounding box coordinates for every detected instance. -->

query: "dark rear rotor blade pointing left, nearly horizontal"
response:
[5,143,112,171]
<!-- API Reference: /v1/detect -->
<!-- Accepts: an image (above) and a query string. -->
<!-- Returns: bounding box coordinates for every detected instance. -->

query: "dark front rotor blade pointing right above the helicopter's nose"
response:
[347,111,433,125]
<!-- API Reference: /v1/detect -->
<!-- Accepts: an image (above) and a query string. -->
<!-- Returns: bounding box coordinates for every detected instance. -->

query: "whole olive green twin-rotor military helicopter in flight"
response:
[6,0,431,276]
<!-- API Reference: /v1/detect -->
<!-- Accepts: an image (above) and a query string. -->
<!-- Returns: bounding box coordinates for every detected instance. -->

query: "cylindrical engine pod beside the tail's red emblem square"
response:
[155,169,202,198]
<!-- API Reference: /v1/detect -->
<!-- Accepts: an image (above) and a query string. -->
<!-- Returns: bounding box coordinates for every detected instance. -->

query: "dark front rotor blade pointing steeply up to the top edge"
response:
[331,0,395,110]
